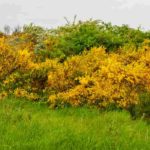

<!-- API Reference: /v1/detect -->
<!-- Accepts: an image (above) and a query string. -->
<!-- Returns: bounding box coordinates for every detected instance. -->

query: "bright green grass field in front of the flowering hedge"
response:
[0,98,150,150]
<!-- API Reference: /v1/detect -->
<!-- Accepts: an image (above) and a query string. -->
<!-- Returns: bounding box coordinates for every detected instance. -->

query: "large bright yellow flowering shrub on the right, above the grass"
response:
[48,48,150,108]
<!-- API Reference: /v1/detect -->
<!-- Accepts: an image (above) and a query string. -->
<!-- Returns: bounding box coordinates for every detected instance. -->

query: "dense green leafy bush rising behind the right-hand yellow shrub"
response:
[45,20,150,57]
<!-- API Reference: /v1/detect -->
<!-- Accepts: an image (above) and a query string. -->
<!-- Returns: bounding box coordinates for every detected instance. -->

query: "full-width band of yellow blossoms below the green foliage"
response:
[0,37,150,108]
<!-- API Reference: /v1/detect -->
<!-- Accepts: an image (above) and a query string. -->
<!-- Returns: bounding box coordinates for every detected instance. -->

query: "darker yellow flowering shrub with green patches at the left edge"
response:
[0,37,57,100]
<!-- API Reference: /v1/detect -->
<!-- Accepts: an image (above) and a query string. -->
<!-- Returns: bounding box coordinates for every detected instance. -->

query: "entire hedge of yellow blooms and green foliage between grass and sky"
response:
[0,20,150,116]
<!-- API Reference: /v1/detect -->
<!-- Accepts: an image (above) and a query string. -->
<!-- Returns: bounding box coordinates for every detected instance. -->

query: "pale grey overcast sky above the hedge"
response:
[0,0,150,30]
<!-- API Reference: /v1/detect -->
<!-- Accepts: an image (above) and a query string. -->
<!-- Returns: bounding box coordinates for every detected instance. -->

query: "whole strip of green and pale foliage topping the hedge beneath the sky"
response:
[6,19,150,58]
